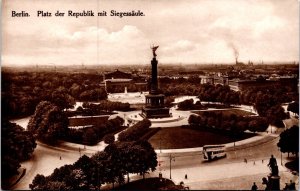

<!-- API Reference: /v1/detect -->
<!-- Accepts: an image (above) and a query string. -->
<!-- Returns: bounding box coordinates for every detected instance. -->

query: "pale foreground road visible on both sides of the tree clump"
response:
[12,132,291,190]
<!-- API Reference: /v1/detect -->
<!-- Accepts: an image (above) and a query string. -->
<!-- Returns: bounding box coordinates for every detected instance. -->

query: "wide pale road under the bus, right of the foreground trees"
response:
[146,136,293,190]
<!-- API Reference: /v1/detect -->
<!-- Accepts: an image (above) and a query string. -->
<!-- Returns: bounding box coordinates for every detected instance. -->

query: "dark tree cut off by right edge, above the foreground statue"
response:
[277,125,299,156]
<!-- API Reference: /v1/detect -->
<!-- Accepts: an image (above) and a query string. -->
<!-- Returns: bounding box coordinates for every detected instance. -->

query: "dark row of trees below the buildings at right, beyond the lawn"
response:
[186,84,297,127]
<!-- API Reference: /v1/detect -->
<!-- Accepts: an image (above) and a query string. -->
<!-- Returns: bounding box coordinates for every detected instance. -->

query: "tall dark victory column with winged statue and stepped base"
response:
[142,46,170,118]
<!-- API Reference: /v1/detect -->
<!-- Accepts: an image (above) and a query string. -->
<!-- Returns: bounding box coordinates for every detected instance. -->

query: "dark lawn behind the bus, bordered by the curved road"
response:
[148,127,255,149]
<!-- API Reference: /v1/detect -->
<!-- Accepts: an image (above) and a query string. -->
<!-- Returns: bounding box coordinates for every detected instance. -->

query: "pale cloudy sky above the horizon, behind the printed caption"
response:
[1,0,299,66]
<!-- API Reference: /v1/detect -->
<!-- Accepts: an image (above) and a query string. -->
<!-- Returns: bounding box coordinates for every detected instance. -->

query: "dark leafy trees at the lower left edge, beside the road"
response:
[1,120,36,181]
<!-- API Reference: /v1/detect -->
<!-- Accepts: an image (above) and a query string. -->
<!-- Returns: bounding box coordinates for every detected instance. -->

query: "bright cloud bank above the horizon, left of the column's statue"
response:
[3,25,150,65]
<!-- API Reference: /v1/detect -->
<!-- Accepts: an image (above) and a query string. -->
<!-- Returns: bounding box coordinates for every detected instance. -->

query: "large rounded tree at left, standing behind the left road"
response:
[27,101,69,144]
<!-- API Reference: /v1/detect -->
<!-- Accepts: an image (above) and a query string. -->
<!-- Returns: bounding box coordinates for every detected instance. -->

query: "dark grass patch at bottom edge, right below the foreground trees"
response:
[115,178,175,190]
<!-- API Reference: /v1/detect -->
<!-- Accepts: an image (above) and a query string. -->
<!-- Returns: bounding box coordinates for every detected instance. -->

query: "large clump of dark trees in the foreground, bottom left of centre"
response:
[29,141,157,190]
